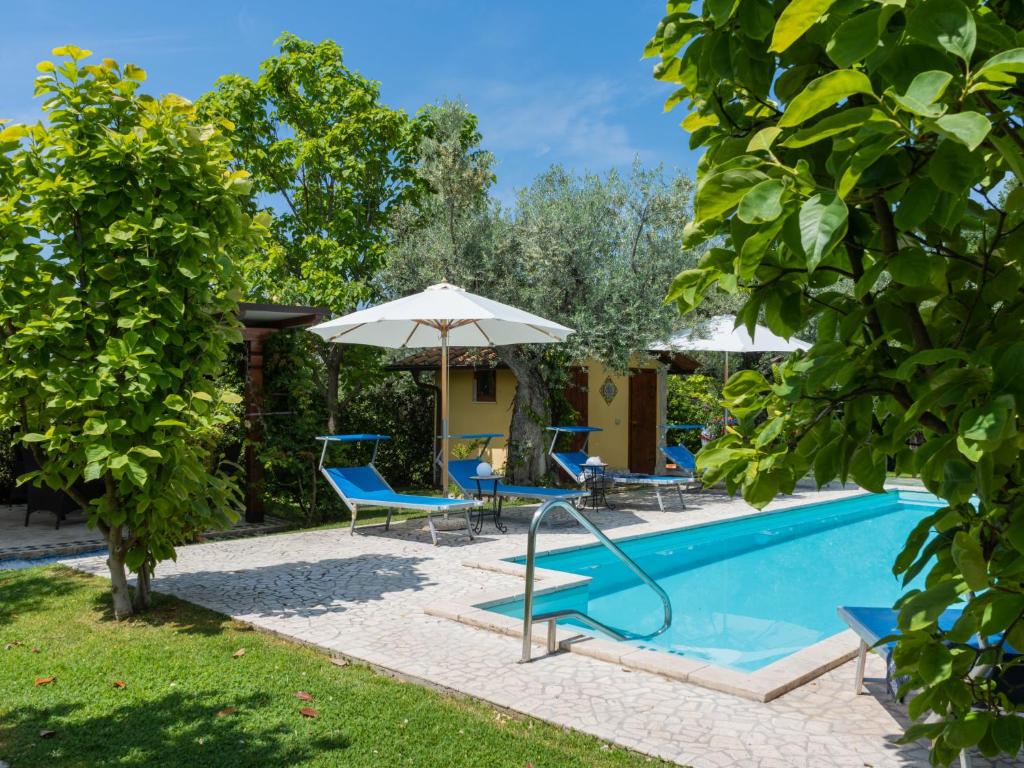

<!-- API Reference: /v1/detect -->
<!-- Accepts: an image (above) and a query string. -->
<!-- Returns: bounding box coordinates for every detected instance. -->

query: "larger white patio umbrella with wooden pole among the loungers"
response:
[309,283,574,489]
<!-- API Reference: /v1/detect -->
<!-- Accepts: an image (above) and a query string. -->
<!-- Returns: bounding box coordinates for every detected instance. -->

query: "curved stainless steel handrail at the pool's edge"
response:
[519,499,672,662]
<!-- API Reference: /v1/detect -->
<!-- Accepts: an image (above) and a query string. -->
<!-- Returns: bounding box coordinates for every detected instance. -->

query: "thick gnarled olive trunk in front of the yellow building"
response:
[499,347,551,484]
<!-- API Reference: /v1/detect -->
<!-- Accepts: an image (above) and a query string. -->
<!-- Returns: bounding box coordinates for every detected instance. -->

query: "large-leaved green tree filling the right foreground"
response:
[646,0,1024,763]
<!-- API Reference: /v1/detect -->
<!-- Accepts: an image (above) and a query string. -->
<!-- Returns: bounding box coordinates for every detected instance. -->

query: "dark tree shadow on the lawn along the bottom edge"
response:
[0,691,349,768]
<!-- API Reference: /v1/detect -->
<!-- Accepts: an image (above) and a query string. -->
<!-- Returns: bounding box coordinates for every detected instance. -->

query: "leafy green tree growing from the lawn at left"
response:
[0,46,261,617]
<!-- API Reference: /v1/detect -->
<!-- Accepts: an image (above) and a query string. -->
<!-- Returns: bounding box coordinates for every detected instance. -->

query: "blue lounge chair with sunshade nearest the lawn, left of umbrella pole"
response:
[316,434,477,545]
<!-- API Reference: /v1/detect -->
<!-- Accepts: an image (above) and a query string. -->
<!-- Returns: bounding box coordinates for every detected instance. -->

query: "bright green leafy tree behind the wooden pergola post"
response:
[199,33,428,432]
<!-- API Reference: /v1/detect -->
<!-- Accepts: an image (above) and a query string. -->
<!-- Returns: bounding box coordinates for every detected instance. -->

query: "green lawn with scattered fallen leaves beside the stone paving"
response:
[0,566,665,768]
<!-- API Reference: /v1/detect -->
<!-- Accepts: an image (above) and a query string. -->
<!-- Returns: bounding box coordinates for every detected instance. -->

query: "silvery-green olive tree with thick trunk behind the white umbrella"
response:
[384,103,693,482]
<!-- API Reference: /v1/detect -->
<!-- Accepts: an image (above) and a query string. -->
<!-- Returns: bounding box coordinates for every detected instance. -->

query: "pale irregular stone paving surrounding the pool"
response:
[71,490,1020,768]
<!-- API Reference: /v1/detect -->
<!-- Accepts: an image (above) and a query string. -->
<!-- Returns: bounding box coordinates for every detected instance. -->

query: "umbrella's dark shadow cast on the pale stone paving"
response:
[146,554,435,632]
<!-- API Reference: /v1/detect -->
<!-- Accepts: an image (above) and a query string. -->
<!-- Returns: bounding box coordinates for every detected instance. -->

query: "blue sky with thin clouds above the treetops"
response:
[0,0,696,202]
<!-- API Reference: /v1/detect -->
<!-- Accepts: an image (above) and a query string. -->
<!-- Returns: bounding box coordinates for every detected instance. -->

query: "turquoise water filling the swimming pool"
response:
[487,492,944,672]
